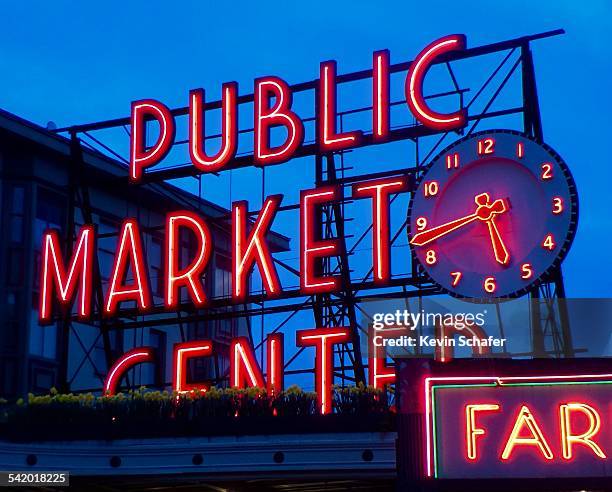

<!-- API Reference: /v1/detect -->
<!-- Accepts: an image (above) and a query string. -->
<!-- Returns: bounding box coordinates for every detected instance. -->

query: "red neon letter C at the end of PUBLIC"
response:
[406,34,467,130]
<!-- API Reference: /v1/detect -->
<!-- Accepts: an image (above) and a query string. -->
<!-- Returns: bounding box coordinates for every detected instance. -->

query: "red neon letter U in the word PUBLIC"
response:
[189,82,238,172]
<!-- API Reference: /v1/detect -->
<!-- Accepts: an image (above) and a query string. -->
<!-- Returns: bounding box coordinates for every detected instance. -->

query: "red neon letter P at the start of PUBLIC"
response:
[130,99,175,181]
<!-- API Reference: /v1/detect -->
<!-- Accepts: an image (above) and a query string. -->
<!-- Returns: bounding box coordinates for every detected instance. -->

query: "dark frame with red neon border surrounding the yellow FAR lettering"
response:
[395,358,612,490]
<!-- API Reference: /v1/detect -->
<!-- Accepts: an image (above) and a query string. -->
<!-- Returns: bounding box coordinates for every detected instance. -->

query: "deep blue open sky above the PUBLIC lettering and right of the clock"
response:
[0,0,612,297]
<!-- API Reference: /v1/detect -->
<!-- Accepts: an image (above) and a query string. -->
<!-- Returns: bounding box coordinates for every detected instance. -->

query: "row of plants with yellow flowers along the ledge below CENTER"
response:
[0,384,391,440]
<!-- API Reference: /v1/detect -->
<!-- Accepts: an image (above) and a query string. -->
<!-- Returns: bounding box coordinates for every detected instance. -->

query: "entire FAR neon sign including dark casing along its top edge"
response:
[400,360,612,480]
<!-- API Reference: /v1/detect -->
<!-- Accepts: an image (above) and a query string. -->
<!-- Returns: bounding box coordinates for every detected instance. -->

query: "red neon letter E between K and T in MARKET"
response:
[300,186,340,294]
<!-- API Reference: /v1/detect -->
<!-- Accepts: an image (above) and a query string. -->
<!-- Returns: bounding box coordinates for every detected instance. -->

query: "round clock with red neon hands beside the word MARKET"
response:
[408,130,578,299]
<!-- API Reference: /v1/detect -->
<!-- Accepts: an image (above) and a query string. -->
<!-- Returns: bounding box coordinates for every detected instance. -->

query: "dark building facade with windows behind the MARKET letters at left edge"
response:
[0,111,288,398]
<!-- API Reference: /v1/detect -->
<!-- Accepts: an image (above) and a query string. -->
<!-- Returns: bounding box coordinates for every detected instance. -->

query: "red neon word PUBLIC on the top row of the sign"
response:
[130,35,467,183]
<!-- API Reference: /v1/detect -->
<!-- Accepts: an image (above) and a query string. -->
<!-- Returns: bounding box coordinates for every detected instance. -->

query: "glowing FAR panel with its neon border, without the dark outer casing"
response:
[425,374,612,478]
